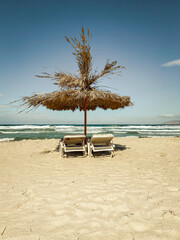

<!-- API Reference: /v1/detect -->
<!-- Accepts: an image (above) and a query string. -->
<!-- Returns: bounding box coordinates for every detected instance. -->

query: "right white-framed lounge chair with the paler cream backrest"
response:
[88,134,115,157]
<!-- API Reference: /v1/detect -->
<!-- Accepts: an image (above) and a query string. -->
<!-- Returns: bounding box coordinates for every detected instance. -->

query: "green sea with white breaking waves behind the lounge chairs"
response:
[0,124,180,141]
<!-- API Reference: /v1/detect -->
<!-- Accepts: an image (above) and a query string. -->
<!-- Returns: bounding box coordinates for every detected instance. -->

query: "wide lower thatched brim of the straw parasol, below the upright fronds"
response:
[17,89,130,111]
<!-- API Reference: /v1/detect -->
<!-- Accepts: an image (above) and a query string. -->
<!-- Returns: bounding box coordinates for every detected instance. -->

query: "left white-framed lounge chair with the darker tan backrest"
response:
[59,135,86,157]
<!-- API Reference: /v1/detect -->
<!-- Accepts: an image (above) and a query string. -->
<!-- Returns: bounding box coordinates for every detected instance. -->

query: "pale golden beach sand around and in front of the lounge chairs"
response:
[0,138,180,240]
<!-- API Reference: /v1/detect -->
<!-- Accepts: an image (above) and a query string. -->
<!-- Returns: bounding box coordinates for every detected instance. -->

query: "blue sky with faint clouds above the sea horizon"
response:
[0,0,180,124]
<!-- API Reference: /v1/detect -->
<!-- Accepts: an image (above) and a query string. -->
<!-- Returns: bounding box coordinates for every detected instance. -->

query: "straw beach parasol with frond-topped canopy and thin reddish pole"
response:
[18,27,133,139]
